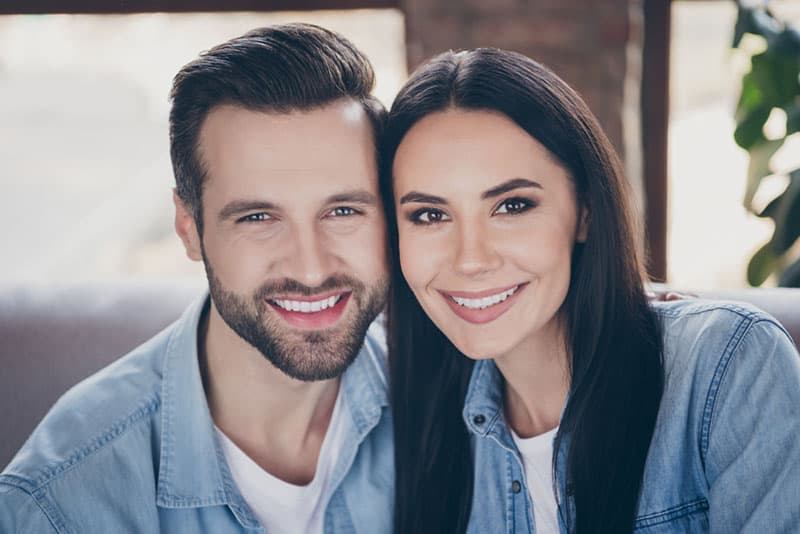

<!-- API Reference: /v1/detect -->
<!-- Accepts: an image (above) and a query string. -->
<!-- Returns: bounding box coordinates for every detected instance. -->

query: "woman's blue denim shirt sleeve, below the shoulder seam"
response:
[701,319,800,533]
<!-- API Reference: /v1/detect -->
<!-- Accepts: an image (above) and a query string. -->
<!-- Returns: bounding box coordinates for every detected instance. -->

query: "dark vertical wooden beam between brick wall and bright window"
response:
[641,0,670,282]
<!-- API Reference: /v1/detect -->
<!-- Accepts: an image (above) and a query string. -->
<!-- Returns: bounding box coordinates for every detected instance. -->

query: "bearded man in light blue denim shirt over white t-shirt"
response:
[0,24,394,534]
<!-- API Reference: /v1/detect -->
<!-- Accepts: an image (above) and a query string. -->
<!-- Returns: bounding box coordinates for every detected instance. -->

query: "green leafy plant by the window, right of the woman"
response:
[733,0,800,287]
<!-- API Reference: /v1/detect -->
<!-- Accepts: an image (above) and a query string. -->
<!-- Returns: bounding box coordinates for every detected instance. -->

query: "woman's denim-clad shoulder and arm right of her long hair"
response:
[637,299,800,532]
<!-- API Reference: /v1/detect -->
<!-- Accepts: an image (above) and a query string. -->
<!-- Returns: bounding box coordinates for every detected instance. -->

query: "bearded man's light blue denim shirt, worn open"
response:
[0,296,394,534]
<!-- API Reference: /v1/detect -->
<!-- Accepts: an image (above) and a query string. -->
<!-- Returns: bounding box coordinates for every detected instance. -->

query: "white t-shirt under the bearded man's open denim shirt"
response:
[215,389,345,534]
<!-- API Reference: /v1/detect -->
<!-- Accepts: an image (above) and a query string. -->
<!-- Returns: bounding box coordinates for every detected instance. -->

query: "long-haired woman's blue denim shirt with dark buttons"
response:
[463,300,800,534]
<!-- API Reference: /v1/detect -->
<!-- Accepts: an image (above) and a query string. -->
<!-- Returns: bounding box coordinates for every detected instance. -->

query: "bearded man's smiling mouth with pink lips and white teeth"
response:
[267,290,351,330]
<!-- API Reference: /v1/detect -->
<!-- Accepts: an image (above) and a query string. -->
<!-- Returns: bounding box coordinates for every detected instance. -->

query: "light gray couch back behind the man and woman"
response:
[0,281,800,467]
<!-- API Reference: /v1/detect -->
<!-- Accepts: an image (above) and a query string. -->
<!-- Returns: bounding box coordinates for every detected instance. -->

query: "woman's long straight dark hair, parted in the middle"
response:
[381,48,663,534]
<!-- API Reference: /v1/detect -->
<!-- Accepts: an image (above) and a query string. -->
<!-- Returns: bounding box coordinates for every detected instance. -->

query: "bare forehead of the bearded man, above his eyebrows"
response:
[200,101,377,203]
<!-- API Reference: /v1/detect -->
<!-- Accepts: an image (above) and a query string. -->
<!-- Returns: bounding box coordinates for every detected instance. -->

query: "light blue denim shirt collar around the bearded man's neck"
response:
[157,294,389,529]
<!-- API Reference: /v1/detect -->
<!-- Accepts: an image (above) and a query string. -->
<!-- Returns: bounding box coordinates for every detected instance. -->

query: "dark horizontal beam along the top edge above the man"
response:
[0,0,399,15]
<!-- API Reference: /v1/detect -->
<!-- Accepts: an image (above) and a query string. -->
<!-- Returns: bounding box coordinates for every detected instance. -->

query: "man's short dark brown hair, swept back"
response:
[169,23,385,234]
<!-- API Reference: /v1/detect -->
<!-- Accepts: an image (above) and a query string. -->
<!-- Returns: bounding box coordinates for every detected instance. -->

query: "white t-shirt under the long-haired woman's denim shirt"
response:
[511,427,559,534]
